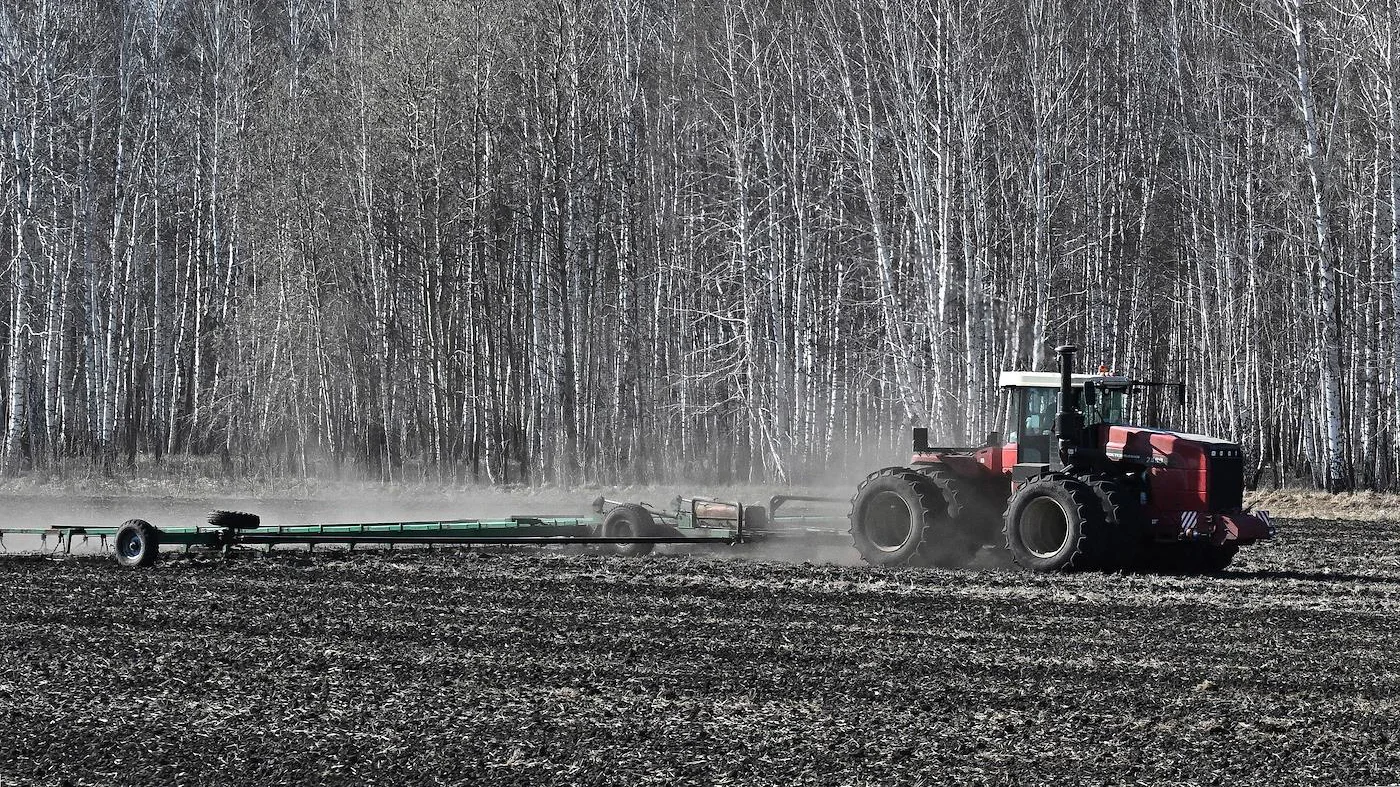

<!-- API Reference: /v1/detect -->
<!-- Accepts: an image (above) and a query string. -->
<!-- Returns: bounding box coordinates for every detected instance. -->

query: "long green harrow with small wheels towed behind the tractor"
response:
[0,494,848,569]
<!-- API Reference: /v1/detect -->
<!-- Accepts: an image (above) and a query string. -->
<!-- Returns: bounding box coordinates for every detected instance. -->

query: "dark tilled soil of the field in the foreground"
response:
[0,521,1400,786]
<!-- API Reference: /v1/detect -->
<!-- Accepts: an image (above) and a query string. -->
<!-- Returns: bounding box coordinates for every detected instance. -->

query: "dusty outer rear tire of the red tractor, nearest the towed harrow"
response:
[850,468,967,566]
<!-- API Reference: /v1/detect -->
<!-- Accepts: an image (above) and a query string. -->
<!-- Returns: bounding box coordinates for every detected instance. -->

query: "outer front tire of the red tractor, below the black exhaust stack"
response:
[1002,473,1105,571]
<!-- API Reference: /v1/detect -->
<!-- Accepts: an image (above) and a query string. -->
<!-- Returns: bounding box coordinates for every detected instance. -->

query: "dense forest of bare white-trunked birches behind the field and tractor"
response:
[0,0,1400,489]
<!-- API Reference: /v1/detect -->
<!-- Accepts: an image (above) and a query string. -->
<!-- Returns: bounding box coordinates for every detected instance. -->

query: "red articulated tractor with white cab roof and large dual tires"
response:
[851,346,1275,573]
